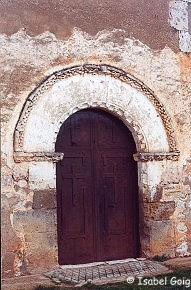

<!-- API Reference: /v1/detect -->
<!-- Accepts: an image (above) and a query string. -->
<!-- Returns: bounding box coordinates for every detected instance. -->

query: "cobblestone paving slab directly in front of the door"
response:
[44,259,168,284]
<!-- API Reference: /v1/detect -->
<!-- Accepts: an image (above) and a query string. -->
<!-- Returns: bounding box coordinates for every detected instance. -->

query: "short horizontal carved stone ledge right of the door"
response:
[133,151,180,162]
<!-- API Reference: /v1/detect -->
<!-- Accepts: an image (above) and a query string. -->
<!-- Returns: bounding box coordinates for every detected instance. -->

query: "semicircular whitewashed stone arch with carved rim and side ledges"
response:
[14,64,179,161]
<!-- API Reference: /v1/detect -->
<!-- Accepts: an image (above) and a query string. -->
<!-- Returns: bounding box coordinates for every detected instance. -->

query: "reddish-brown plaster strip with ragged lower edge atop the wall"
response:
[0,0,178,50]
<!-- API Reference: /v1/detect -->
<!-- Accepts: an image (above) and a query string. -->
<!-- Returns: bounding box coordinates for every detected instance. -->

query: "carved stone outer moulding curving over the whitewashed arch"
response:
[14,64,178,154]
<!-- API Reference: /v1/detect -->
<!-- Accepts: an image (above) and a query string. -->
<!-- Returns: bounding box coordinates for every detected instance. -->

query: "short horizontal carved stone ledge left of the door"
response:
[14,152,64,163]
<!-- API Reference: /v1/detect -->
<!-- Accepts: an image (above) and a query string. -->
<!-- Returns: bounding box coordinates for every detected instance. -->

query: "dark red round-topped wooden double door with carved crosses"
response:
[56,109,139,264]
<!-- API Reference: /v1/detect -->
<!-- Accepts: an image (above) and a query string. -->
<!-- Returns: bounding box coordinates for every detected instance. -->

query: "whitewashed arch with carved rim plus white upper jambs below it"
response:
[10,65,185,255]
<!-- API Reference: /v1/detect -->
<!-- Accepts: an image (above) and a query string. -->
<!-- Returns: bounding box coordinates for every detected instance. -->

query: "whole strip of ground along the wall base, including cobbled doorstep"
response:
[1,257,191,290]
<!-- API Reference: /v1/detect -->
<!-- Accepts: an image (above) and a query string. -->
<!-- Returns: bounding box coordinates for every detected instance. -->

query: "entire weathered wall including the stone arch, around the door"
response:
[0,0,191,277]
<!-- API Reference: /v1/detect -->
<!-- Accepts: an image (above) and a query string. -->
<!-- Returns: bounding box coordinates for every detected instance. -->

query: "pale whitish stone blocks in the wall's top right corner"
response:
[169,0,191,52]
